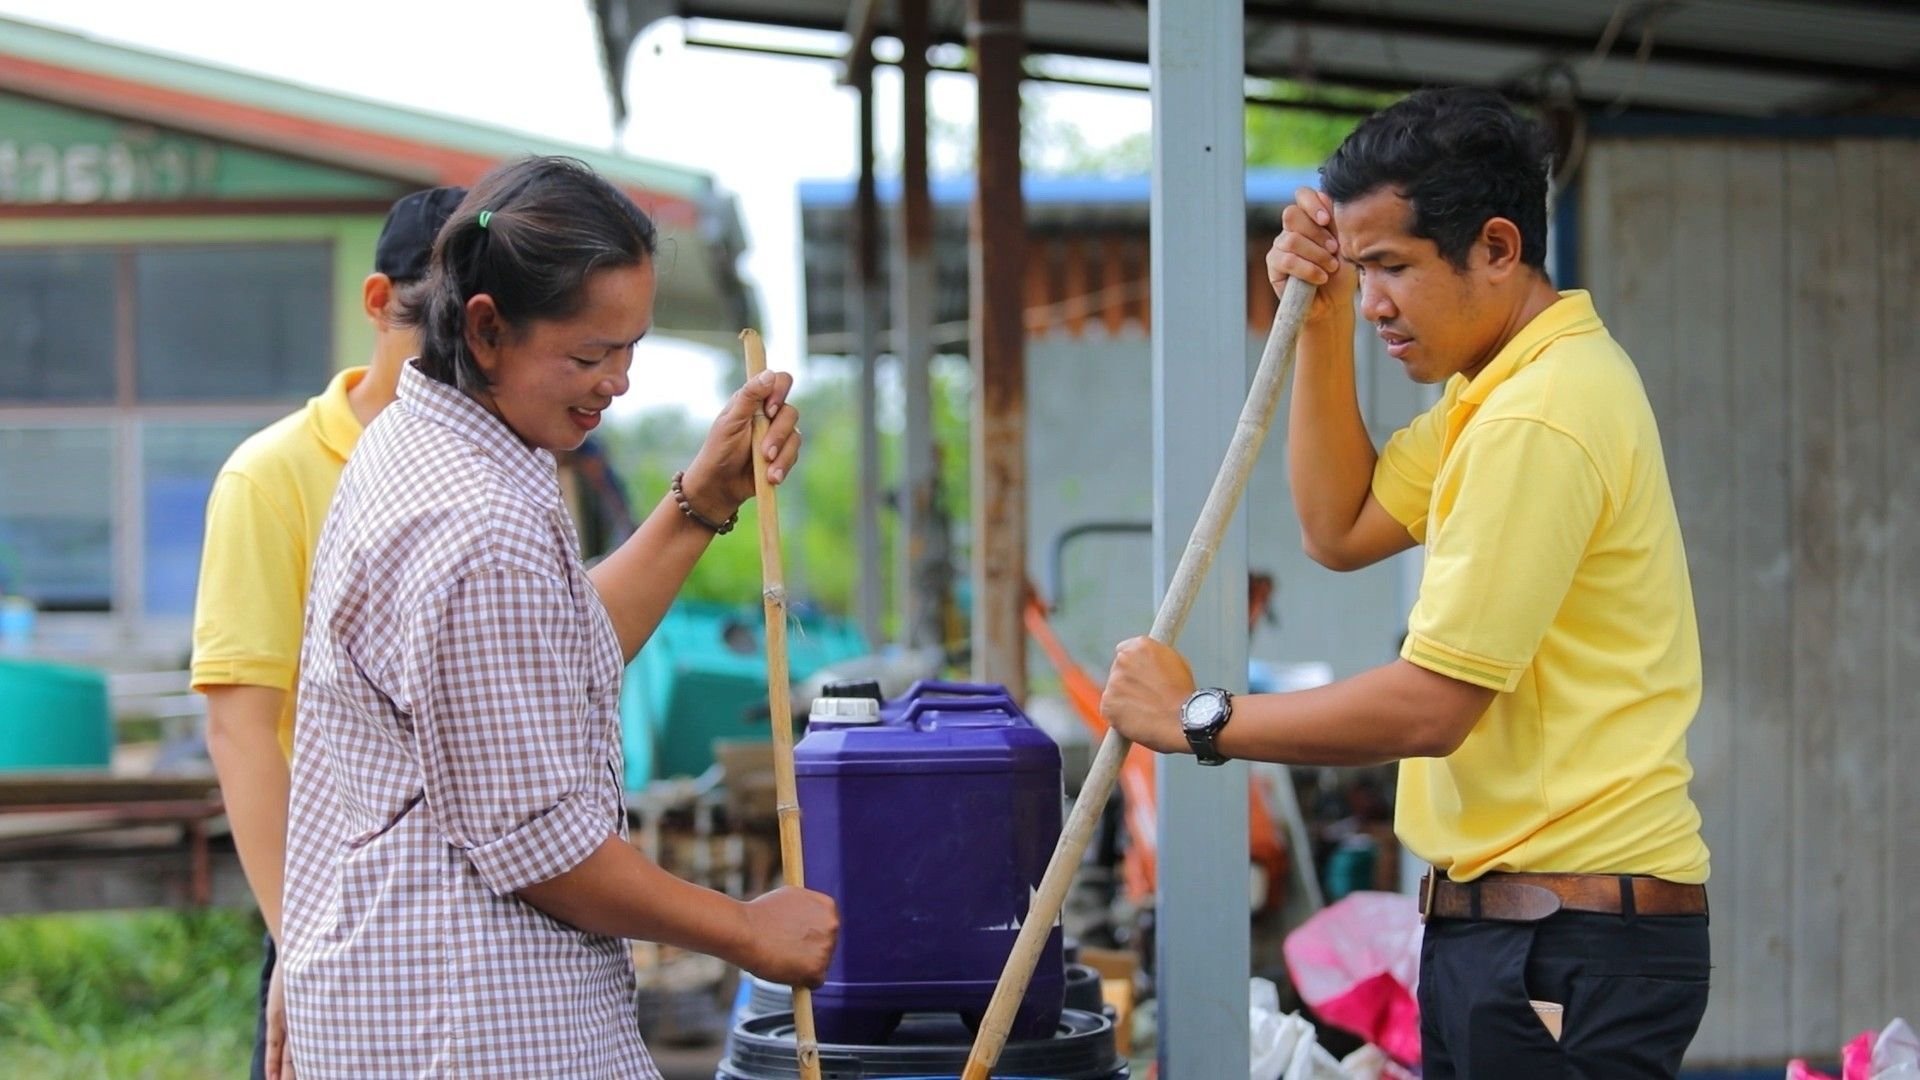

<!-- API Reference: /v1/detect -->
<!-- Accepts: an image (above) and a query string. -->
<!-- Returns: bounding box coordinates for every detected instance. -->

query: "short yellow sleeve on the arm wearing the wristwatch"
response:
[1400,419,1611,692]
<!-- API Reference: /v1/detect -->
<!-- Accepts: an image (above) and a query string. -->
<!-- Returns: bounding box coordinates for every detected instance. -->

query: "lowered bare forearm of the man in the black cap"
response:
[207,686,292,942]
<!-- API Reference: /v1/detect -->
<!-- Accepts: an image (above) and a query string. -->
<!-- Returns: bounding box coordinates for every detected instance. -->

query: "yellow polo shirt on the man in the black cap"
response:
[192,367,367,759]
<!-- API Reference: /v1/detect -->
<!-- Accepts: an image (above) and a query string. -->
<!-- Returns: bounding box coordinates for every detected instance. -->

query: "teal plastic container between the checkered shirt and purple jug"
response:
[620,600,868,780]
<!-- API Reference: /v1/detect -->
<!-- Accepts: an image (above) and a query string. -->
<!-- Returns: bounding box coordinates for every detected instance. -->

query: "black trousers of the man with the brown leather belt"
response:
[1419,911,1709,1080]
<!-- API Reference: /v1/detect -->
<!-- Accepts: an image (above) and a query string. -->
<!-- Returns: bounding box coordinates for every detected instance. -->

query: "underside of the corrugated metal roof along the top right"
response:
[597,0,1920,115]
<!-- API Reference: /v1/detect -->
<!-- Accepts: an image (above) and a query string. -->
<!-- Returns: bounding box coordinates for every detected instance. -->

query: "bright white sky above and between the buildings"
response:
[0,0,1150,419]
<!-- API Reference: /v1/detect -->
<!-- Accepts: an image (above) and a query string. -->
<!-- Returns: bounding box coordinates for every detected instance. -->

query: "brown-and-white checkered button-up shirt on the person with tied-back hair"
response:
[280,365,659,1080]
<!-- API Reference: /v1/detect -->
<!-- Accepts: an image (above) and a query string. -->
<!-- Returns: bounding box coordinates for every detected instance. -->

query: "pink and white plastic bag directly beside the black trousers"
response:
[1283,892,1421,1065]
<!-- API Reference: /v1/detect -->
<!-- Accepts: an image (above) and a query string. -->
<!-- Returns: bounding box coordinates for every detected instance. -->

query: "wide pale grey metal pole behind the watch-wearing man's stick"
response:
[1148,0,1250,1078]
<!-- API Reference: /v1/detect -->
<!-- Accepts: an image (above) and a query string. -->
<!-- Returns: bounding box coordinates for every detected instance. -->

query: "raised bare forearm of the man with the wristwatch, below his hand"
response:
[1286,311,1375,548]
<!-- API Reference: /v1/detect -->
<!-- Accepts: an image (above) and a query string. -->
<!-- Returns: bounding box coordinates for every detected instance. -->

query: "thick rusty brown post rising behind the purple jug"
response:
[968,0,1027,700]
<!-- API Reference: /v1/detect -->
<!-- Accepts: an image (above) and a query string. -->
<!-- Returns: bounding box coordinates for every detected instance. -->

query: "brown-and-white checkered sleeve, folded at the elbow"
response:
[407,569,620,896]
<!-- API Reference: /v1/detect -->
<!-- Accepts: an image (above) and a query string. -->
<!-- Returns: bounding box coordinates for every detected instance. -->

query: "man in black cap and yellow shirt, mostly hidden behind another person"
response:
[192,188,467,1080]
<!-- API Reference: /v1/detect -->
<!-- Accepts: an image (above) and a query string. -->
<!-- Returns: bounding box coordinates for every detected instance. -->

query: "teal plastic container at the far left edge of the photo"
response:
[0,657,113,773]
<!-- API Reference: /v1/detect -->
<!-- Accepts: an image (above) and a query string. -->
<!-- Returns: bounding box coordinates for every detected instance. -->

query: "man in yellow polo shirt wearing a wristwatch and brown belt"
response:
[1102,90,1709,1080]
